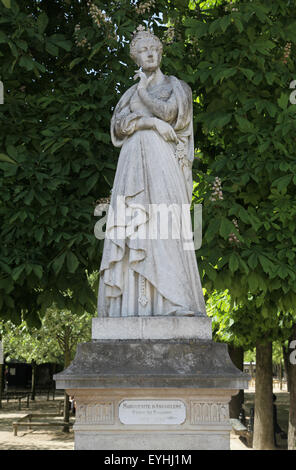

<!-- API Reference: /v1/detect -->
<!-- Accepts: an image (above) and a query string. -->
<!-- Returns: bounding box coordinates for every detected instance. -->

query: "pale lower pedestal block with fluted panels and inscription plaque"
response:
[68,389,236,450]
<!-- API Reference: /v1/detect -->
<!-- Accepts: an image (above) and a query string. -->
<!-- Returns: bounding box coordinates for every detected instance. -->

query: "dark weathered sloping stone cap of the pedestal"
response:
[55,339,248,389]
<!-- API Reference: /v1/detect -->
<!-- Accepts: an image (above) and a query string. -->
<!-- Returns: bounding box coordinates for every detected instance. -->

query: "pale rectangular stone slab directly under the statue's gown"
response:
[92,316,212,340]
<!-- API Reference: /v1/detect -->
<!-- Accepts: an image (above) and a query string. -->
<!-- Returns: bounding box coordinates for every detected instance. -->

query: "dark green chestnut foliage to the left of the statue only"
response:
[0,0,171,324]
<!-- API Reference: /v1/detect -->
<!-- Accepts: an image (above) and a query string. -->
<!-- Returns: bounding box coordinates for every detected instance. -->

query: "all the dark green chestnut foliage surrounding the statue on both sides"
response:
[0,0,296,335]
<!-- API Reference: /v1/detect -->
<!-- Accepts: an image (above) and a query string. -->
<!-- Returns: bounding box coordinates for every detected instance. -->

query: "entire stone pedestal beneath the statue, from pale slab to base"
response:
[55,317,249,450]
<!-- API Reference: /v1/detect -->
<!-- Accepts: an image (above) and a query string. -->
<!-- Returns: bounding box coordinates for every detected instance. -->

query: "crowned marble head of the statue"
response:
[130,27,162,72]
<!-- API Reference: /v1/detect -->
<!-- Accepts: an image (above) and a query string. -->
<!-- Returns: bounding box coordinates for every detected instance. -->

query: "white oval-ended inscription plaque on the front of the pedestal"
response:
[118,400,186,425]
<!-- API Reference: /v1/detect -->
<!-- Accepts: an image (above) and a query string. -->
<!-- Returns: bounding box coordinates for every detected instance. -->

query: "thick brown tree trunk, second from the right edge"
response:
[253,342,274,450]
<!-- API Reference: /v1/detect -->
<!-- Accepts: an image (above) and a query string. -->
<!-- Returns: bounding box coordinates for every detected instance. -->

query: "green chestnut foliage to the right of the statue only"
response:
[188,2,296,343]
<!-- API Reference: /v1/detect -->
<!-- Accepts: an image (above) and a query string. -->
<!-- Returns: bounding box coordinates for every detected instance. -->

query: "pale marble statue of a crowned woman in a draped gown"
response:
[98,29,206,317]
